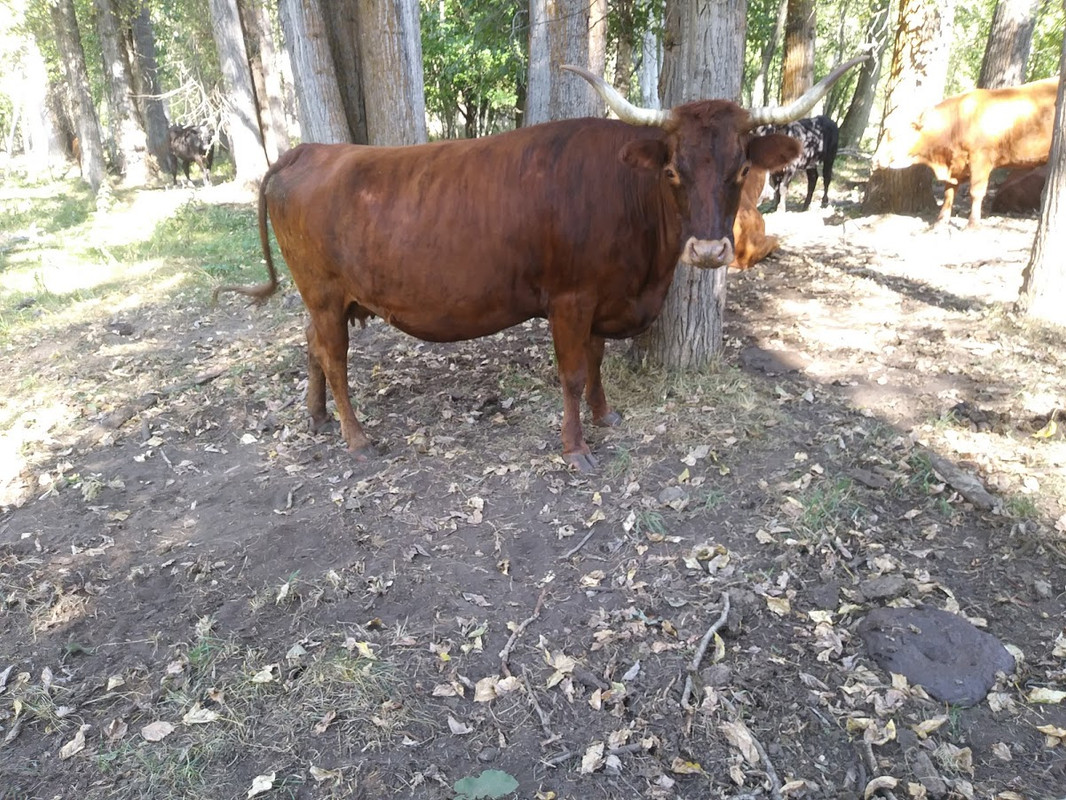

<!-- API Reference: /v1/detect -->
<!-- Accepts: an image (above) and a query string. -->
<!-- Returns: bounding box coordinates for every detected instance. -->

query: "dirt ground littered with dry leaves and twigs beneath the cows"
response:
[0,181,1066,800]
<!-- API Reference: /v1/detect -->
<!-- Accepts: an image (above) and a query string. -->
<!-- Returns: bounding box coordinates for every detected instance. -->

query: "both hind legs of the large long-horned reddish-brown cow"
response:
[307,309,373,460]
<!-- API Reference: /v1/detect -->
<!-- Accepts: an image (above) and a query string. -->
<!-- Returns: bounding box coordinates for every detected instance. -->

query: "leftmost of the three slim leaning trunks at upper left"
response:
[49,0,108,197]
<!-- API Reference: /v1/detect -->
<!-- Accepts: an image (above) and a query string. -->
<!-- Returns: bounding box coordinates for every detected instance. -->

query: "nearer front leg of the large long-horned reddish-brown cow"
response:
[549,299,607,473]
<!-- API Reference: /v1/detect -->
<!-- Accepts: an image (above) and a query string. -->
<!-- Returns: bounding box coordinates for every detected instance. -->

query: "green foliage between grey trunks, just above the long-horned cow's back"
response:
[421,0,528,139]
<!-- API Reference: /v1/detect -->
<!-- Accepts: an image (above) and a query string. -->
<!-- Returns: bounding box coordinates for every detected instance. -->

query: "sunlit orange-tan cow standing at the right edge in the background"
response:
[874,78,1059,227]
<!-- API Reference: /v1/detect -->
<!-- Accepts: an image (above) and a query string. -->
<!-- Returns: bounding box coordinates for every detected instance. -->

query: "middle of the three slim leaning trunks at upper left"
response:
[95,0,148,187]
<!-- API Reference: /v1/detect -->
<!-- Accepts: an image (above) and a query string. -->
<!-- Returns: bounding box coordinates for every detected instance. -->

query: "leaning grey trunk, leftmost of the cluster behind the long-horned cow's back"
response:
[280,0,354,144]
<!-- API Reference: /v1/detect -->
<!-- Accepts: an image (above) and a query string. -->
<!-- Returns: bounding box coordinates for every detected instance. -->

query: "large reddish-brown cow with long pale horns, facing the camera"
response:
[215,59,861,470]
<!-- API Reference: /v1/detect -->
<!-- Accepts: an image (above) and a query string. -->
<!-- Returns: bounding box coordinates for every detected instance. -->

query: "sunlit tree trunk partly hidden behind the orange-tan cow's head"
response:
[862,0,955,215]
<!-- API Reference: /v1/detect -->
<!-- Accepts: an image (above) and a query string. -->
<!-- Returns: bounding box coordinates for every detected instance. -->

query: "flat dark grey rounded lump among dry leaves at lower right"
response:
[858,607,1014,706]
